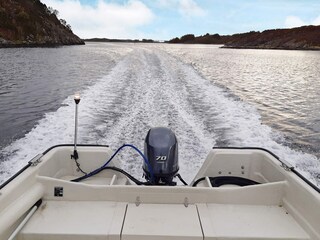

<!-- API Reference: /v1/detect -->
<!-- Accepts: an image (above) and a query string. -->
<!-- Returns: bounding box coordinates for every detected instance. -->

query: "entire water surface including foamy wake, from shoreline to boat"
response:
[0,43,320,185]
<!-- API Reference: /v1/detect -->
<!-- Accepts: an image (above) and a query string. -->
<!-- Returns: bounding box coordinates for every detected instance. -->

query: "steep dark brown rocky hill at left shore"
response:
[0,0,84,47]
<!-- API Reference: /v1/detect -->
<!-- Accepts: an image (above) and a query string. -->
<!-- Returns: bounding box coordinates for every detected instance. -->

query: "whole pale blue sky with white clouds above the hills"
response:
[41,0,320,40]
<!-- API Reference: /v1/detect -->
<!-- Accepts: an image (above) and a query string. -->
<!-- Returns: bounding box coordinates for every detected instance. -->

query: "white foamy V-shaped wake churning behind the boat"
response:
[1,47,320,188]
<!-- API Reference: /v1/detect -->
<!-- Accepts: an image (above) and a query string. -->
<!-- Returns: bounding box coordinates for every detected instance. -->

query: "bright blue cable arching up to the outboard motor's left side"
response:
[73,144,155,183]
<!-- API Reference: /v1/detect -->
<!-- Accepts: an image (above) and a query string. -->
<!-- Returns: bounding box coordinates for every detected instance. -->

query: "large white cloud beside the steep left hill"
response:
[42,0,154,38]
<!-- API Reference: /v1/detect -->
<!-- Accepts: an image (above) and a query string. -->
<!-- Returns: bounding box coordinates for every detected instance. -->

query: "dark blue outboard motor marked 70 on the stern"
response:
[143,127,179,186]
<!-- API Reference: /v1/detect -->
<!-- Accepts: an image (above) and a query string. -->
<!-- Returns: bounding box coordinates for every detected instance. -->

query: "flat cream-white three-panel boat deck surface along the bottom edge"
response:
[18,201,310,240]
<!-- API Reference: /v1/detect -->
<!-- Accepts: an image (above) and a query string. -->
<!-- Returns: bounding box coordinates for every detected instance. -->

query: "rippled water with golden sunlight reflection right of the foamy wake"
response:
[167,45,320,157]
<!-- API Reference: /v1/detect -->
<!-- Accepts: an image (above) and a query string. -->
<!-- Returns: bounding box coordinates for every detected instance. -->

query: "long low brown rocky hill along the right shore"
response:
[169,26,320,50]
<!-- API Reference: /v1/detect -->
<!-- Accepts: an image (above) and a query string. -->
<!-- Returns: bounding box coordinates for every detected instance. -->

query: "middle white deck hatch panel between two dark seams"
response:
[121,204,203,240]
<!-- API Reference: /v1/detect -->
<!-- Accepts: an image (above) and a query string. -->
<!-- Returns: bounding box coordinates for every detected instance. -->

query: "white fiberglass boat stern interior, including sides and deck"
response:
[0,146,320,240]
